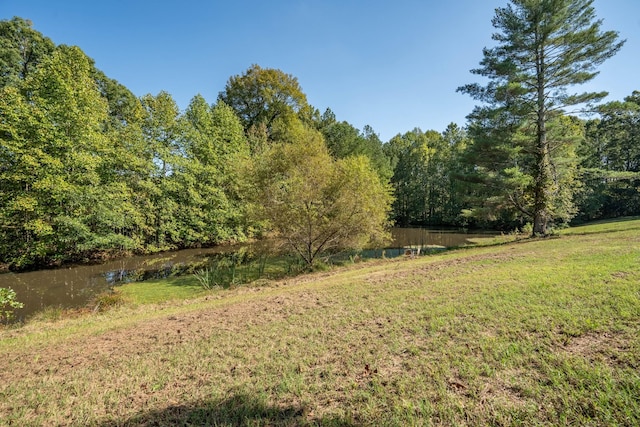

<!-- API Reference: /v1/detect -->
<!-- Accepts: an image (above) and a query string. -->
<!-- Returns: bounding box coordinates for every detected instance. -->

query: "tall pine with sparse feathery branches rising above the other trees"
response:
[458,0,624,235]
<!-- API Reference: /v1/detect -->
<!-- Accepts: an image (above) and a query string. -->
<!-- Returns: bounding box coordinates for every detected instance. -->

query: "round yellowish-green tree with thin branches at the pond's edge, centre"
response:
[247,129,392,267]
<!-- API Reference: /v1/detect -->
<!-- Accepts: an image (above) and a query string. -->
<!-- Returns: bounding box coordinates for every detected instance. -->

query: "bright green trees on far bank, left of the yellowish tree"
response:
[0,25,248,269]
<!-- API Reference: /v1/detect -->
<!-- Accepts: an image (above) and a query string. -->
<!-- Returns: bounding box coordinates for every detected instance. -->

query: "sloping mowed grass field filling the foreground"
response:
[0,219,640,426]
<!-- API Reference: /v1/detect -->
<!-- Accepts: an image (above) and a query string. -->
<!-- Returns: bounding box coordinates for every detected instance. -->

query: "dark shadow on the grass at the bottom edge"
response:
[99,394,355,427]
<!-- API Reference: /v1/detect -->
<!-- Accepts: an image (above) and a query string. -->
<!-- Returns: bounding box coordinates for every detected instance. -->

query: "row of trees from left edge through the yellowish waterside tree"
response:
[0,18,391,269]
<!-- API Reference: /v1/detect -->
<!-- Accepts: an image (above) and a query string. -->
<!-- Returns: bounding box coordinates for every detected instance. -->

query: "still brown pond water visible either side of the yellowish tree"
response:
[0,228,486,320]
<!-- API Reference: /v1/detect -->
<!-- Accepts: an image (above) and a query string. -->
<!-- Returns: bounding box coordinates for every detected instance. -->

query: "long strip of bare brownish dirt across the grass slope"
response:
[0,288,327,383]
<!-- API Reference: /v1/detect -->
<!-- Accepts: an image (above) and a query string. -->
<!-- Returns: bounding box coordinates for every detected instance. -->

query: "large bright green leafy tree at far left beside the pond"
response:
[0,46,115,266]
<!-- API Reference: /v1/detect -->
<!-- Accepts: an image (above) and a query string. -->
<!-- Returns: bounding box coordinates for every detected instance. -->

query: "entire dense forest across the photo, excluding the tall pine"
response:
[0,11,640,269]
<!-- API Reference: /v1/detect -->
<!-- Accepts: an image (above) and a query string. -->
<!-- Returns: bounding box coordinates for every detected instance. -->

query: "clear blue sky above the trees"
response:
[0,0,640,141]
